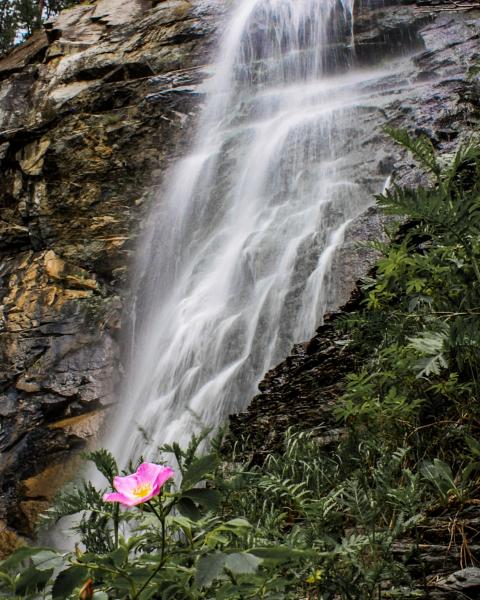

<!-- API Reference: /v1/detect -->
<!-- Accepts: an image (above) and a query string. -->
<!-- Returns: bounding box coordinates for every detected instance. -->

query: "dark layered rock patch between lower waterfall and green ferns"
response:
[225,298,357,464]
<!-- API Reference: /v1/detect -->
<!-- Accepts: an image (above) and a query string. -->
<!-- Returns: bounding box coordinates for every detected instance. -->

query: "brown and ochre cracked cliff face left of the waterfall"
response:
[0,0,221,539]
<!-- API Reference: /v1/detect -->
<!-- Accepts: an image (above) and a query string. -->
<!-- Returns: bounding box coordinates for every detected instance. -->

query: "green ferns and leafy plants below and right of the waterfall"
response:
[0,130,480,600]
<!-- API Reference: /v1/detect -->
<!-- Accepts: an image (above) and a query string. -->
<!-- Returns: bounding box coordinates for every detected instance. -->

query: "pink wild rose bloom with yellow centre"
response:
[103,463,174,506]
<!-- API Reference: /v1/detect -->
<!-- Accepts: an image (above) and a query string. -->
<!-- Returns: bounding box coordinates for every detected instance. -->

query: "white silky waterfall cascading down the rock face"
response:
[110,0,404,461]
